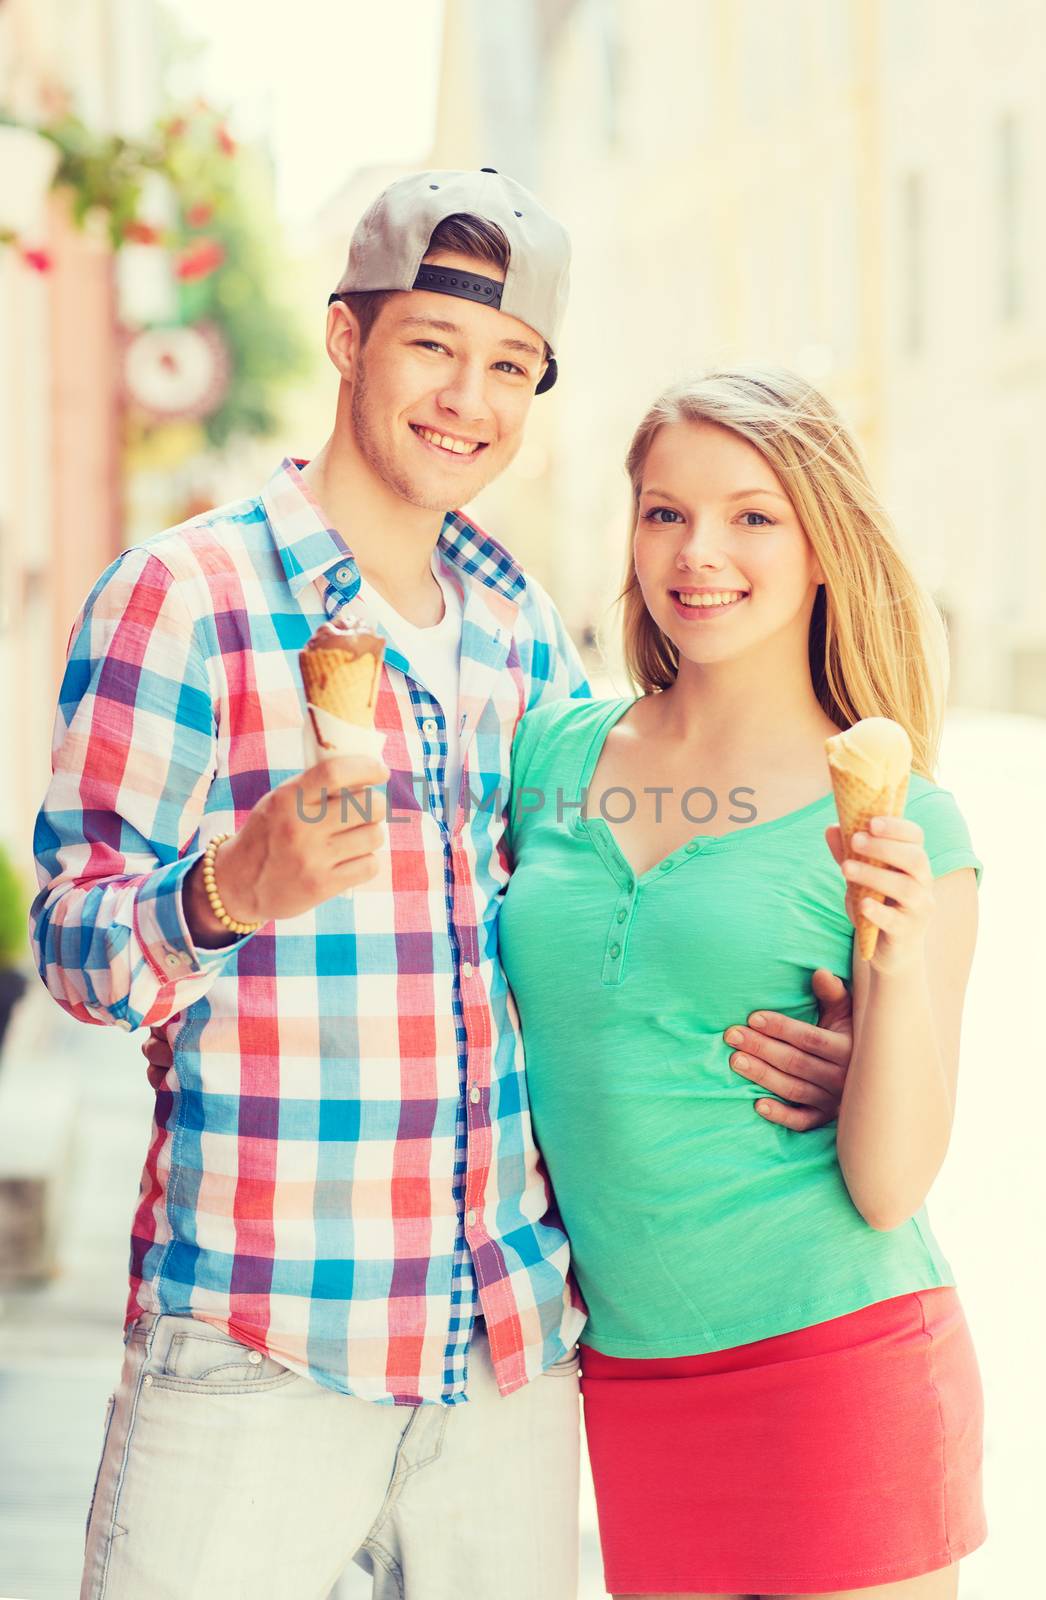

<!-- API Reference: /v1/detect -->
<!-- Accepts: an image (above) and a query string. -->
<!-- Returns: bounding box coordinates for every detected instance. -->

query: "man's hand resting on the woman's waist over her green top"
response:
[725,966,854,1133]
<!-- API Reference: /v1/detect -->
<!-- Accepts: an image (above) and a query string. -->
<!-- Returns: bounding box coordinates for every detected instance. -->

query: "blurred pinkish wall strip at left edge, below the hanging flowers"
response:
[0,202,118,859]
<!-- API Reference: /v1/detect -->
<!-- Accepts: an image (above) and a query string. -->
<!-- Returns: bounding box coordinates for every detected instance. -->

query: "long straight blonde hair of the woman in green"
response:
[617,366,948,781]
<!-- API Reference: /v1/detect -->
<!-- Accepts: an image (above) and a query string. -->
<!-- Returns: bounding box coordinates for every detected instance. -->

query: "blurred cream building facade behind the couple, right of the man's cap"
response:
[433,0,1046,715]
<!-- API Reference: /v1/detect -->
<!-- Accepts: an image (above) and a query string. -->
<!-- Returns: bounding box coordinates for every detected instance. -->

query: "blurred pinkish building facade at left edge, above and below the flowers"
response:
[0,0,155,880]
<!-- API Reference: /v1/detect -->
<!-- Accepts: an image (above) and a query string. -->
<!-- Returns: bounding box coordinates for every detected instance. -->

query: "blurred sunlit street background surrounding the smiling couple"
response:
[0,0,1046,1600]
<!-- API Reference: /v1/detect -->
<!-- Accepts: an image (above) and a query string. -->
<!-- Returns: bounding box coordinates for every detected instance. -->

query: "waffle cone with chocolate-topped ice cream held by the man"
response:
[297,618,385,766]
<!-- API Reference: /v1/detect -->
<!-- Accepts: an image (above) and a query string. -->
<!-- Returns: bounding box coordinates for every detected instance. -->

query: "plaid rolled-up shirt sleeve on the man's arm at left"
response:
[29,547,253,1029]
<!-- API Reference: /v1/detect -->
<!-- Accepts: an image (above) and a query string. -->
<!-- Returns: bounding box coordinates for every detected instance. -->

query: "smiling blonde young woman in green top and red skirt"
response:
[501,370,985,1600]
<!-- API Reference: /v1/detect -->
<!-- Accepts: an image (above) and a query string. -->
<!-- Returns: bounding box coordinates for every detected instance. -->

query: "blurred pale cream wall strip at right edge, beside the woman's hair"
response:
[880,0,1046,714]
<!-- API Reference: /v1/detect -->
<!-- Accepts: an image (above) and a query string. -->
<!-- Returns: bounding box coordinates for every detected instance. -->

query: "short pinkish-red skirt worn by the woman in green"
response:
[581,1288,987,1595]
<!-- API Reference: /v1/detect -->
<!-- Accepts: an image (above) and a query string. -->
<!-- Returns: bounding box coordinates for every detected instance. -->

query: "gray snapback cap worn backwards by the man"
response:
[331,166,571,394]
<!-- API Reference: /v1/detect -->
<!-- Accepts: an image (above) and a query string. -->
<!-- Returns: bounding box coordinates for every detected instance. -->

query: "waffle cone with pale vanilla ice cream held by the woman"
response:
[825,717,912,962]
